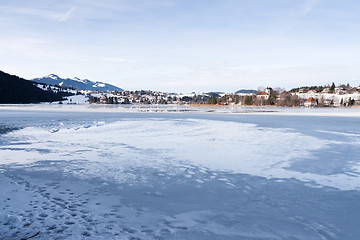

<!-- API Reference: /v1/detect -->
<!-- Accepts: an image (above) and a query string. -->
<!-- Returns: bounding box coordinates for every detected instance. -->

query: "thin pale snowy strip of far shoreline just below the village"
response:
[0,104,360,117]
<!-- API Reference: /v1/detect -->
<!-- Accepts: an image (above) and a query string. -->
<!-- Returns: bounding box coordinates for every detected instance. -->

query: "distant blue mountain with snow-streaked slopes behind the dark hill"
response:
[32,74,123,91]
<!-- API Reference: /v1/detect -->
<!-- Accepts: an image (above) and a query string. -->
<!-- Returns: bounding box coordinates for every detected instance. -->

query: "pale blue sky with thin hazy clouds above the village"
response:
[0,0,360,93]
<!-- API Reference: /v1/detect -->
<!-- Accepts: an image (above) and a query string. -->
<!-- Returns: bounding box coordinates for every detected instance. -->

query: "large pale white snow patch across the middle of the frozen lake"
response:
[0,119,360,190]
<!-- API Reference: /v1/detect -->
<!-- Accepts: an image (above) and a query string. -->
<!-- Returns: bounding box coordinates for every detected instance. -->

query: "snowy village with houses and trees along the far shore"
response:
[83,83,360,107]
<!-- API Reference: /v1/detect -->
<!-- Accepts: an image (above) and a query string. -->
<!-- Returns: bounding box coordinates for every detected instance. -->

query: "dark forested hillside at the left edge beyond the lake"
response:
[0,71,69,104]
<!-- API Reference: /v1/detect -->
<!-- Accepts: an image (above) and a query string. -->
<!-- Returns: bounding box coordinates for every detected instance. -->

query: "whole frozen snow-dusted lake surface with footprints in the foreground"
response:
[0,105,360,239]
